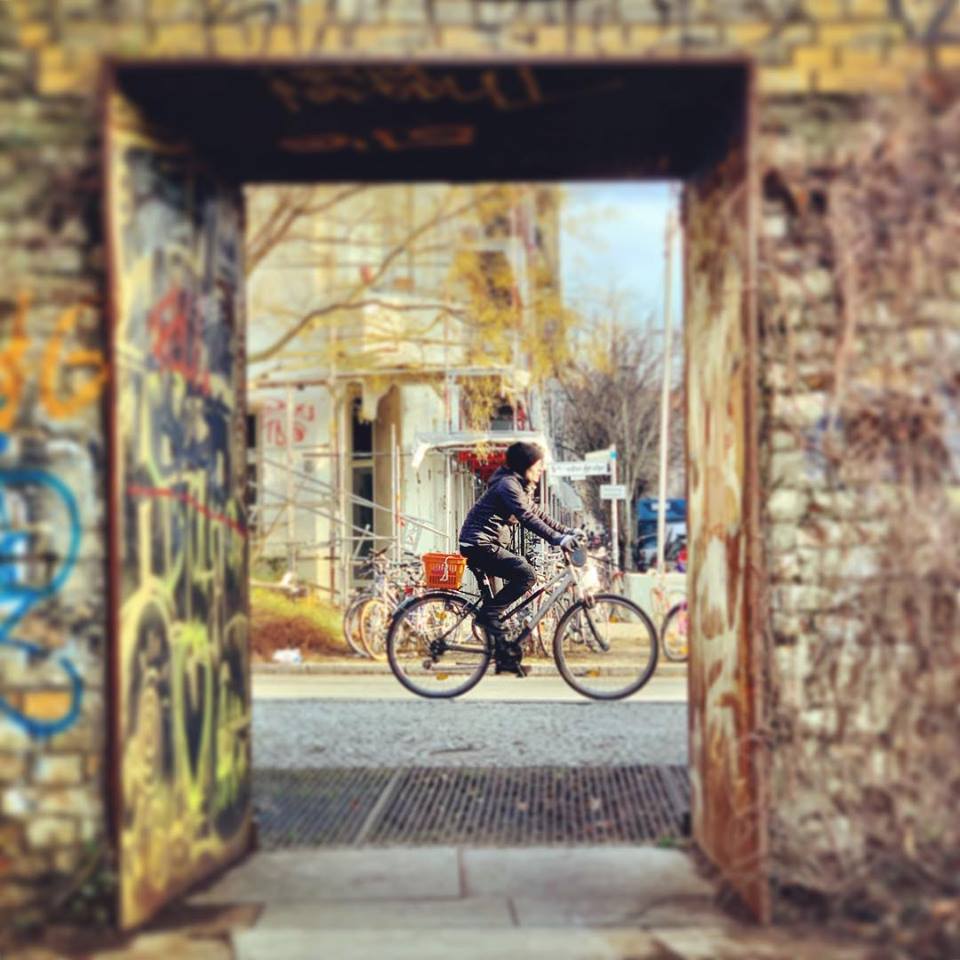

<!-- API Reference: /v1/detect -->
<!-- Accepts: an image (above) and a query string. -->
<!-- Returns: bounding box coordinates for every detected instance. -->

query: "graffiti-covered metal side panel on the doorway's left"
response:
[105,89,251,927]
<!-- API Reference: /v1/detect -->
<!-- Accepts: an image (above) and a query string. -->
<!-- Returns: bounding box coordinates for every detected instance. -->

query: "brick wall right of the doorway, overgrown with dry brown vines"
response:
[761,86,960,957]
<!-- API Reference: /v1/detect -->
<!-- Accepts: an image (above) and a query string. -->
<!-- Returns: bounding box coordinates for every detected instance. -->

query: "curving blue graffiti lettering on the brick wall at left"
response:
[0,456,83,737]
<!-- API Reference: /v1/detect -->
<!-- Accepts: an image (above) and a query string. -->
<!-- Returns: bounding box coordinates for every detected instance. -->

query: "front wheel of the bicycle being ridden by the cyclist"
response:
[553,593,657,700]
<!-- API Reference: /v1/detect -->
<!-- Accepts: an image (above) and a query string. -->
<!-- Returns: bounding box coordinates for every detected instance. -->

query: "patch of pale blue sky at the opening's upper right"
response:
[560,182,683,329]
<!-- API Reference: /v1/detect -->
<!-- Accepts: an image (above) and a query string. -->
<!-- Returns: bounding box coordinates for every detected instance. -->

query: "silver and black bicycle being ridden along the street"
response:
[387,548,659,700]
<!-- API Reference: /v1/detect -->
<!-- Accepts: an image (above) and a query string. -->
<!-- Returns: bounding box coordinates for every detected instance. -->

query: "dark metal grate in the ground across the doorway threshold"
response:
[253,766,690,849]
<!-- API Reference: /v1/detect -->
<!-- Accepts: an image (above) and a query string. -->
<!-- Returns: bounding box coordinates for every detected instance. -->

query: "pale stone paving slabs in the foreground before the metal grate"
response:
[38,847,871,960]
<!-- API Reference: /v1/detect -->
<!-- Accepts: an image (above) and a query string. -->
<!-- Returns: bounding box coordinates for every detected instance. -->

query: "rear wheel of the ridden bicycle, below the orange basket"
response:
[387,592,490,699]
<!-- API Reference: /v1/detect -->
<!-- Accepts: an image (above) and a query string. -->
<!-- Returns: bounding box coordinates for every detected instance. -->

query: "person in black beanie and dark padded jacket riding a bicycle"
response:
[460,441,577,677]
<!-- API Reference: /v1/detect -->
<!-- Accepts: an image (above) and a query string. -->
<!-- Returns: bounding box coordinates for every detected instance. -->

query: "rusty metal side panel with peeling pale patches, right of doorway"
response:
[685,141,769,919]
